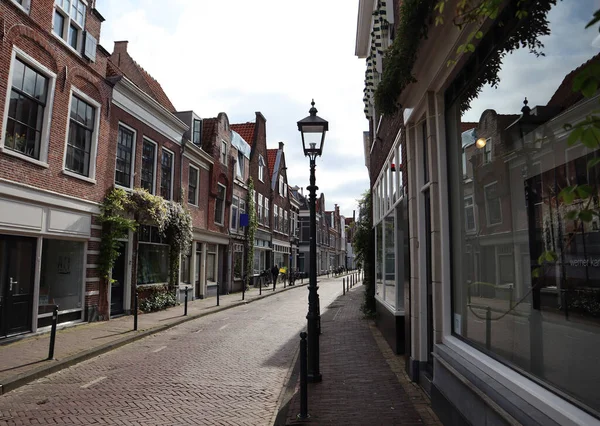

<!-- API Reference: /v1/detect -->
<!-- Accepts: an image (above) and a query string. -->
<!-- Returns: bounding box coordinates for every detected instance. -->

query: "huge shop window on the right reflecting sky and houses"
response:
[446,0,600,415]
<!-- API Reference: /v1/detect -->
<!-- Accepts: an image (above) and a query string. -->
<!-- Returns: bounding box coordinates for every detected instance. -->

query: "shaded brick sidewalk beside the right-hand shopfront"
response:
[286,286,442,426]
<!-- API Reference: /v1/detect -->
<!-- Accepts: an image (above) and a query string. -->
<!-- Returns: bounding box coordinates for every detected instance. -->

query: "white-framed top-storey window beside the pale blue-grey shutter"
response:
[52,0,86,52]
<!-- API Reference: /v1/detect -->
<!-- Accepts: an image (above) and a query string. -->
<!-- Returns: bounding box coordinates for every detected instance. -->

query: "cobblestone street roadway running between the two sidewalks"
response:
[0,280,342,425]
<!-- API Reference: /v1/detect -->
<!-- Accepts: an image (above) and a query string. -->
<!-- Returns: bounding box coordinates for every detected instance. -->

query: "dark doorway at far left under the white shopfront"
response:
[0,235,37,338]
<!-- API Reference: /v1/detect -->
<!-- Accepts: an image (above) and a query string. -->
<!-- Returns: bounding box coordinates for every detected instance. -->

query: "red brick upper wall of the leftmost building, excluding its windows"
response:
[0,0,111,202]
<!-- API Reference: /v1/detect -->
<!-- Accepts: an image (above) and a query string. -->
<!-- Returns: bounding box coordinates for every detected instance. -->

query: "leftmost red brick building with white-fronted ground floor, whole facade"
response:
[0,0,112,338]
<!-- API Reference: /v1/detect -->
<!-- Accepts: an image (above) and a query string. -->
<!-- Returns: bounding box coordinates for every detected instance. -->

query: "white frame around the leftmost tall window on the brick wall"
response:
[0,46,56,168]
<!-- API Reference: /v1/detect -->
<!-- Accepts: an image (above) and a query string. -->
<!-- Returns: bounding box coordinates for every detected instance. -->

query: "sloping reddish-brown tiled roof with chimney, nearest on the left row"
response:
[107,41,176,112]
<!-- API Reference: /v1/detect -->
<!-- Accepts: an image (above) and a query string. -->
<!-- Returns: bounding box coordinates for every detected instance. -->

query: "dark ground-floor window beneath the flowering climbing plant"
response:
[137,225,169,285]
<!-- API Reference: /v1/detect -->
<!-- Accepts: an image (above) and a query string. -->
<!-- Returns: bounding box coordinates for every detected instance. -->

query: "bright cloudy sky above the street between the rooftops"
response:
[96,0,369,217]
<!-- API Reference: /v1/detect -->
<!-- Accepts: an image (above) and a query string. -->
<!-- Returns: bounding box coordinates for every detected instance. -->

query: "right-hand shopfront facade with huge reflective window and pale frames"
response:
[357,1,600,425]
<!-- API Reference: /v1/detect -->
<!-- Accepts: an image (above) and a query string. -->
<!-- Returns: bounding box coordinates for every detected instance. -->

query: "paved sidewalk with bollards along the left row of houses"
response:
[0,277,327,395]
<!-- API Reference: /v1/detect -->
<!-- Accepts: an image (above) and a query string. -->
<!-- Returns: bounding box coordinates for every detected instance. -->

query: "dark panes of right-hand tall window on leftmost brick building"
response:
[65,96,96,177]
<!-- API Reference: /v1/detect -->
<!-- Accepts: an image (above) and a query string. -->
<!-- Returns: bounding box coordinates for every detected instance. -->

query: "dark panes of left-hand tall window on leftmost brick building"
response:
[4,58,48,160]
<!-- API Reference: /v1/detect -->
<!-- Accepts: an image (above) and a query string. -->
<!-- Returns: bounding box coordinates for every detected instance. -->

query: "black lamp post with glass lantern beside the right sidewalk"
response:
[298,99,329,382]
